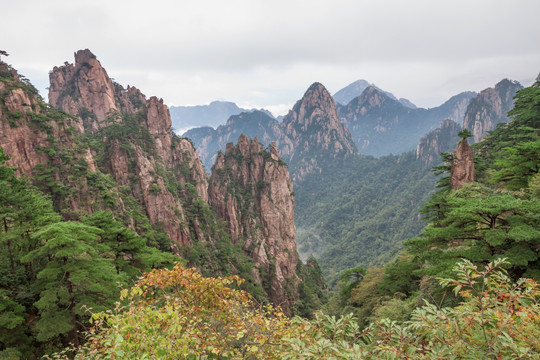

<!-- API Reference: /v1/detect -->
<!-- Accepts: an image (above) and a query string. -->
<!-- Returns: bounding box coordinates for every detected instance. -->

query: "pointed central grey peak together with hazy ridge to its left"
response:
[183,83,358,180]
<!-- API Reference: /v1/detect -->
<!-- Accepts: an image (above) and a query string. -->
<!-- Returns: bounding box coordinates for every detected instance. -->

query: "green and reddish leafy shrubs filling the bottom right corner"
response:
[358,260,540,359]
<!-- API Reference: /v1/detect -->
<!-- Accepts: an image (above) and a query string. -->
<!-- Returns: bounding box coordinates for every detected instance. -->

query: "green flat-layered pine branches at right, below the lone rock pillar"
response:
[408,184,540,279]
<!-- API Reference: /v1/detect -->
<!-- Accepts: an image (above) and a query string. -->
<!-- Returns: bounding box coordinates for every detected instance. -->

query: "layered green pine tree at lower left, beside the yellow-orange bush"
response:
[23,222,118,345]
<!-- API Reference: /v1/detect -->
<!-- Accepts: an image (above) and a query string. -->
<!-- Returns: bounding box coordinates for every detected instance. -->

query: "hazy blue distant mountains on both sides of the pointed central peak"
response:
[183,76,522,172]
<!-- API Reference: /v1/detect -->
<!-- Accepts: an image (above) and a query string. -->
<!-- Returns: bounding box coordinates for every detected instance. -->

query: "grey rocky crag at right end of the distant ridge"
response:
[463,79,523,142]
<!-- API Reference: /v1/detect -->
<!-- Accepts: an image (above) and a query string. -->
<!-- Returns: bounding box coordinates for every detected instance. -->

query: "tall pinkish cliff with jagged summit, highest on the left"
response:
[49,50,207,245]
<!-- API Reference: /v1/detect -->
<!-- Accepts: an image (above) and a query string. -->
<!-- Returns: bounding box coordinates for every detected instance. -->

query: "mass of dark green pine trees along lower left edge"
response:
[0,148,179,358]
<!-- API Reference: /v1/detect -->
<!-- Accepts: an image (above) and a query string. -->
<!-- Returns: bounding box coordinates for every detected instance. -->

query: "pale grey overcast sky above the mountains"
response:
[0,0,540,114]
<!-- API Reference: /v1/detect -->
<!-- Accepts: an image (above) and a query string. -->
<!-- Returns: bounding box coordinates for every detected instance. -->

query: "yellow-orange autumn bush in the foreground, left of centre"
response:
[62,265,288,359]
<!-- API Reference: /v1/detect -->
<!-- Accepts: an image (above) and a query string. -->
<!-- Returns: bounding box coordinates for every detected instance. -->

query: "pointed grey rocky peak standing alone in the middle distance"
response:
[280,83,358,180]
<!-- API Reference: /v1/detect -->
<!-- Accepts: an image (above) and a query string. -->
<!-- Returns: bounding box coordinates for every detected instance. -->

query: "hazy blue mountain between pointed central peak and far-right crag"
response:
[337,86,476,156]
